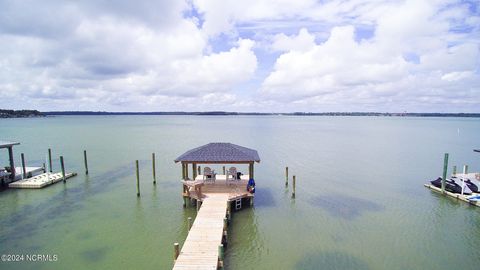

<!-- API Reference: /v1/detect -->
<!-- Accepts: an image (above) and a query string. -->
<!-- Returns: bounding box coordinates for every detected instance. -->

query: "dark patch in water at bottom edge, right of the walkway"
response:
[295,251,370,270]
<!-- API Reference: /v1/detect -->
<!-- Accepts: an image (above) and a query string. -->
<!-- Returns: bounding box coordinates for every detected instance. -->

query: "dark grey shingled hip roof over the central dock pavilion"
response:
[175,143,260,163]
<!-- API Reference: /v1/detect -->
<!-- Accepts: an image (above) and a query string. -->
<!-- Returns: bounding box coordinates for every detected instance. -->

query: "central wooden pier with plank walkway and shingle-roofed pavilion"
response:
[173,143,260,270]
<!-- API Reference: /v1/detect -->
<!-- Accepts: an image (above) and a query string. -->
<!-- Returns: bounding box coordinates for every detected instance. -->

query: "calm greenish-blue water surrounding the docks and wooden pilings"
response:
[0,116,480,270]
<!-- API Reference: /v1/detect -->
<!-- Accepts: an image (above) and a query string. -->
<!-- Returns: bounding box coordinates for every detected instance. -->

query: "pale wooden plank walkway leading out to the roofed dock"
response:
[173,194,228,270]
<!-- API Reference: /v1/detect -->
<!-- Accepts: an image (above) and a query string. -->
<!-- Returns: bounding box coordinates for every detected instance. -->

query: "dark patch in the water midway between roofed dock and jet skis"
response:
[309,194,385,220]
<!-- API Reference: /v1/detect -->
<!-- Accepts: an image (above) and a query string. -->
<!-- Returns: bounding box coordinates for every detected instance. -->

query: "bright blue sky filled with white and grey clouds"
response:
[0,0,480,112]
